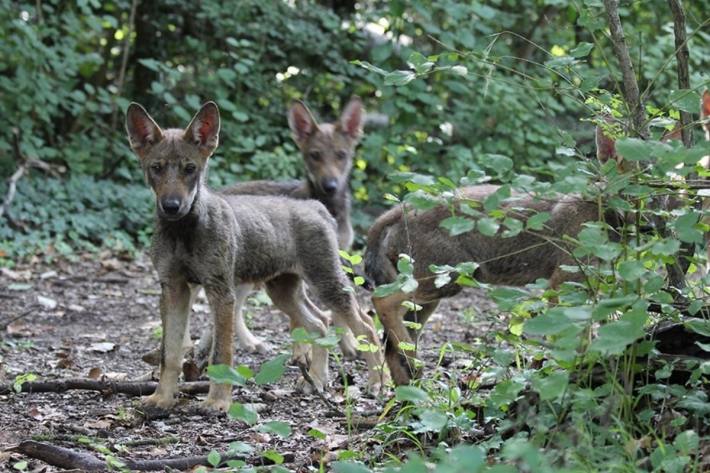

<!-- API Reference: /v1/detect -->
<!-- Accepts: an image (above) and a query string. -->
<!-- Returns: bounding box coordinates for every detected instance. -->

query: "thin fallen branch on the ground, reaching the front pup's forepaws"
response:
[0,378,210,396]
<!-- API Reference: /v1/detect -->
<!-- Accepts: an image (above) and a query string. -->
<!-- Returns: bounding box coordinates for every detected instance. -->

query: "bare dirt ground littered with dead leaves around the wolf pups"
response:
[0,255,496,471]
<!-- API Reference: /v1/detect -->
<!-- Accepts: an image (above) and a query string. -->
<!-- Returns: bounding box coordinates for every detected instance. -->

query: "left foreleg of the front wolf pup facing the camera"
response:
[143,280,191,409]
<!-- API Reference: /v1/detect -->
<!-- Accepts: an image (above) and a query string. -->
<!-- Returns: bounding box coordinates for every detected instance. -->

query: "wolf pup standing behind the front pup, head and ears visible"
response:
[217,97,365,359]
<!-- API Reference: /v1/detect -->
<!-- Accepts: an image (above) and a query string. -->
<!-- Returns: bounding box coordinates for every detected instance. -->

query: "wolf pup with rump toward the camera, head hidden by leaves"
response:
[364,185,599,385]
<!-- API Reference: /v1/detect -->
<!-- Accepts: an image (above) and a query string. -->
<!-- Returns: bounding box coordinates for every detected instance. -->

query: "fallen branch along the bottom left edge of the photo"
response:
[7,440,246,471]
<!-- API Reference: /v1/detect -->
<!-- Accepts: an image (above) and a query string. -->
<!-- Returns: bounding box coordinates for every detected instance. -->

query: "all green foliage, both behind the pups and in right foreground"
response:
[0,0,710,472]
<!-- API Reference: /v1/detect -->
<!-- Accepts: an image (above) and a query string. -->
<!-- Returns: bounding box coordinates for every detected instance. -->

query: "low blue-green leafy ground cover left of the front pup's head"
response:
[0,176,154,261]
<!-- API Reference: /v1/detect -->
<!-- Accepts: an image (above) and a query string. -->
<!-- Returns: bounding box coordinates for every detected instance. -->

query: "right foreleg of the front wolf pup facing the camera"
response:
[203,288,237,412]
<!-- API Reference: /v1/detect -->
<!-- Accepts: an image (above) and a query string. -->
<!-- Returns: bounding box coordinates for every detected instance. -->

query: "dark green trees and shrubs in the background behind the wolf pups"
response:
[0,0,710,259]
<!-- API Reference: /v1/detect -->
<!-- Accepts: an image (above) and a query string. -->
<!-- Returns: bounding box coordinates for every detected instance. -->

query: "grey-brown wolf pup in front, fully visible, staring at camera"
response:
[126,102,384,410]
